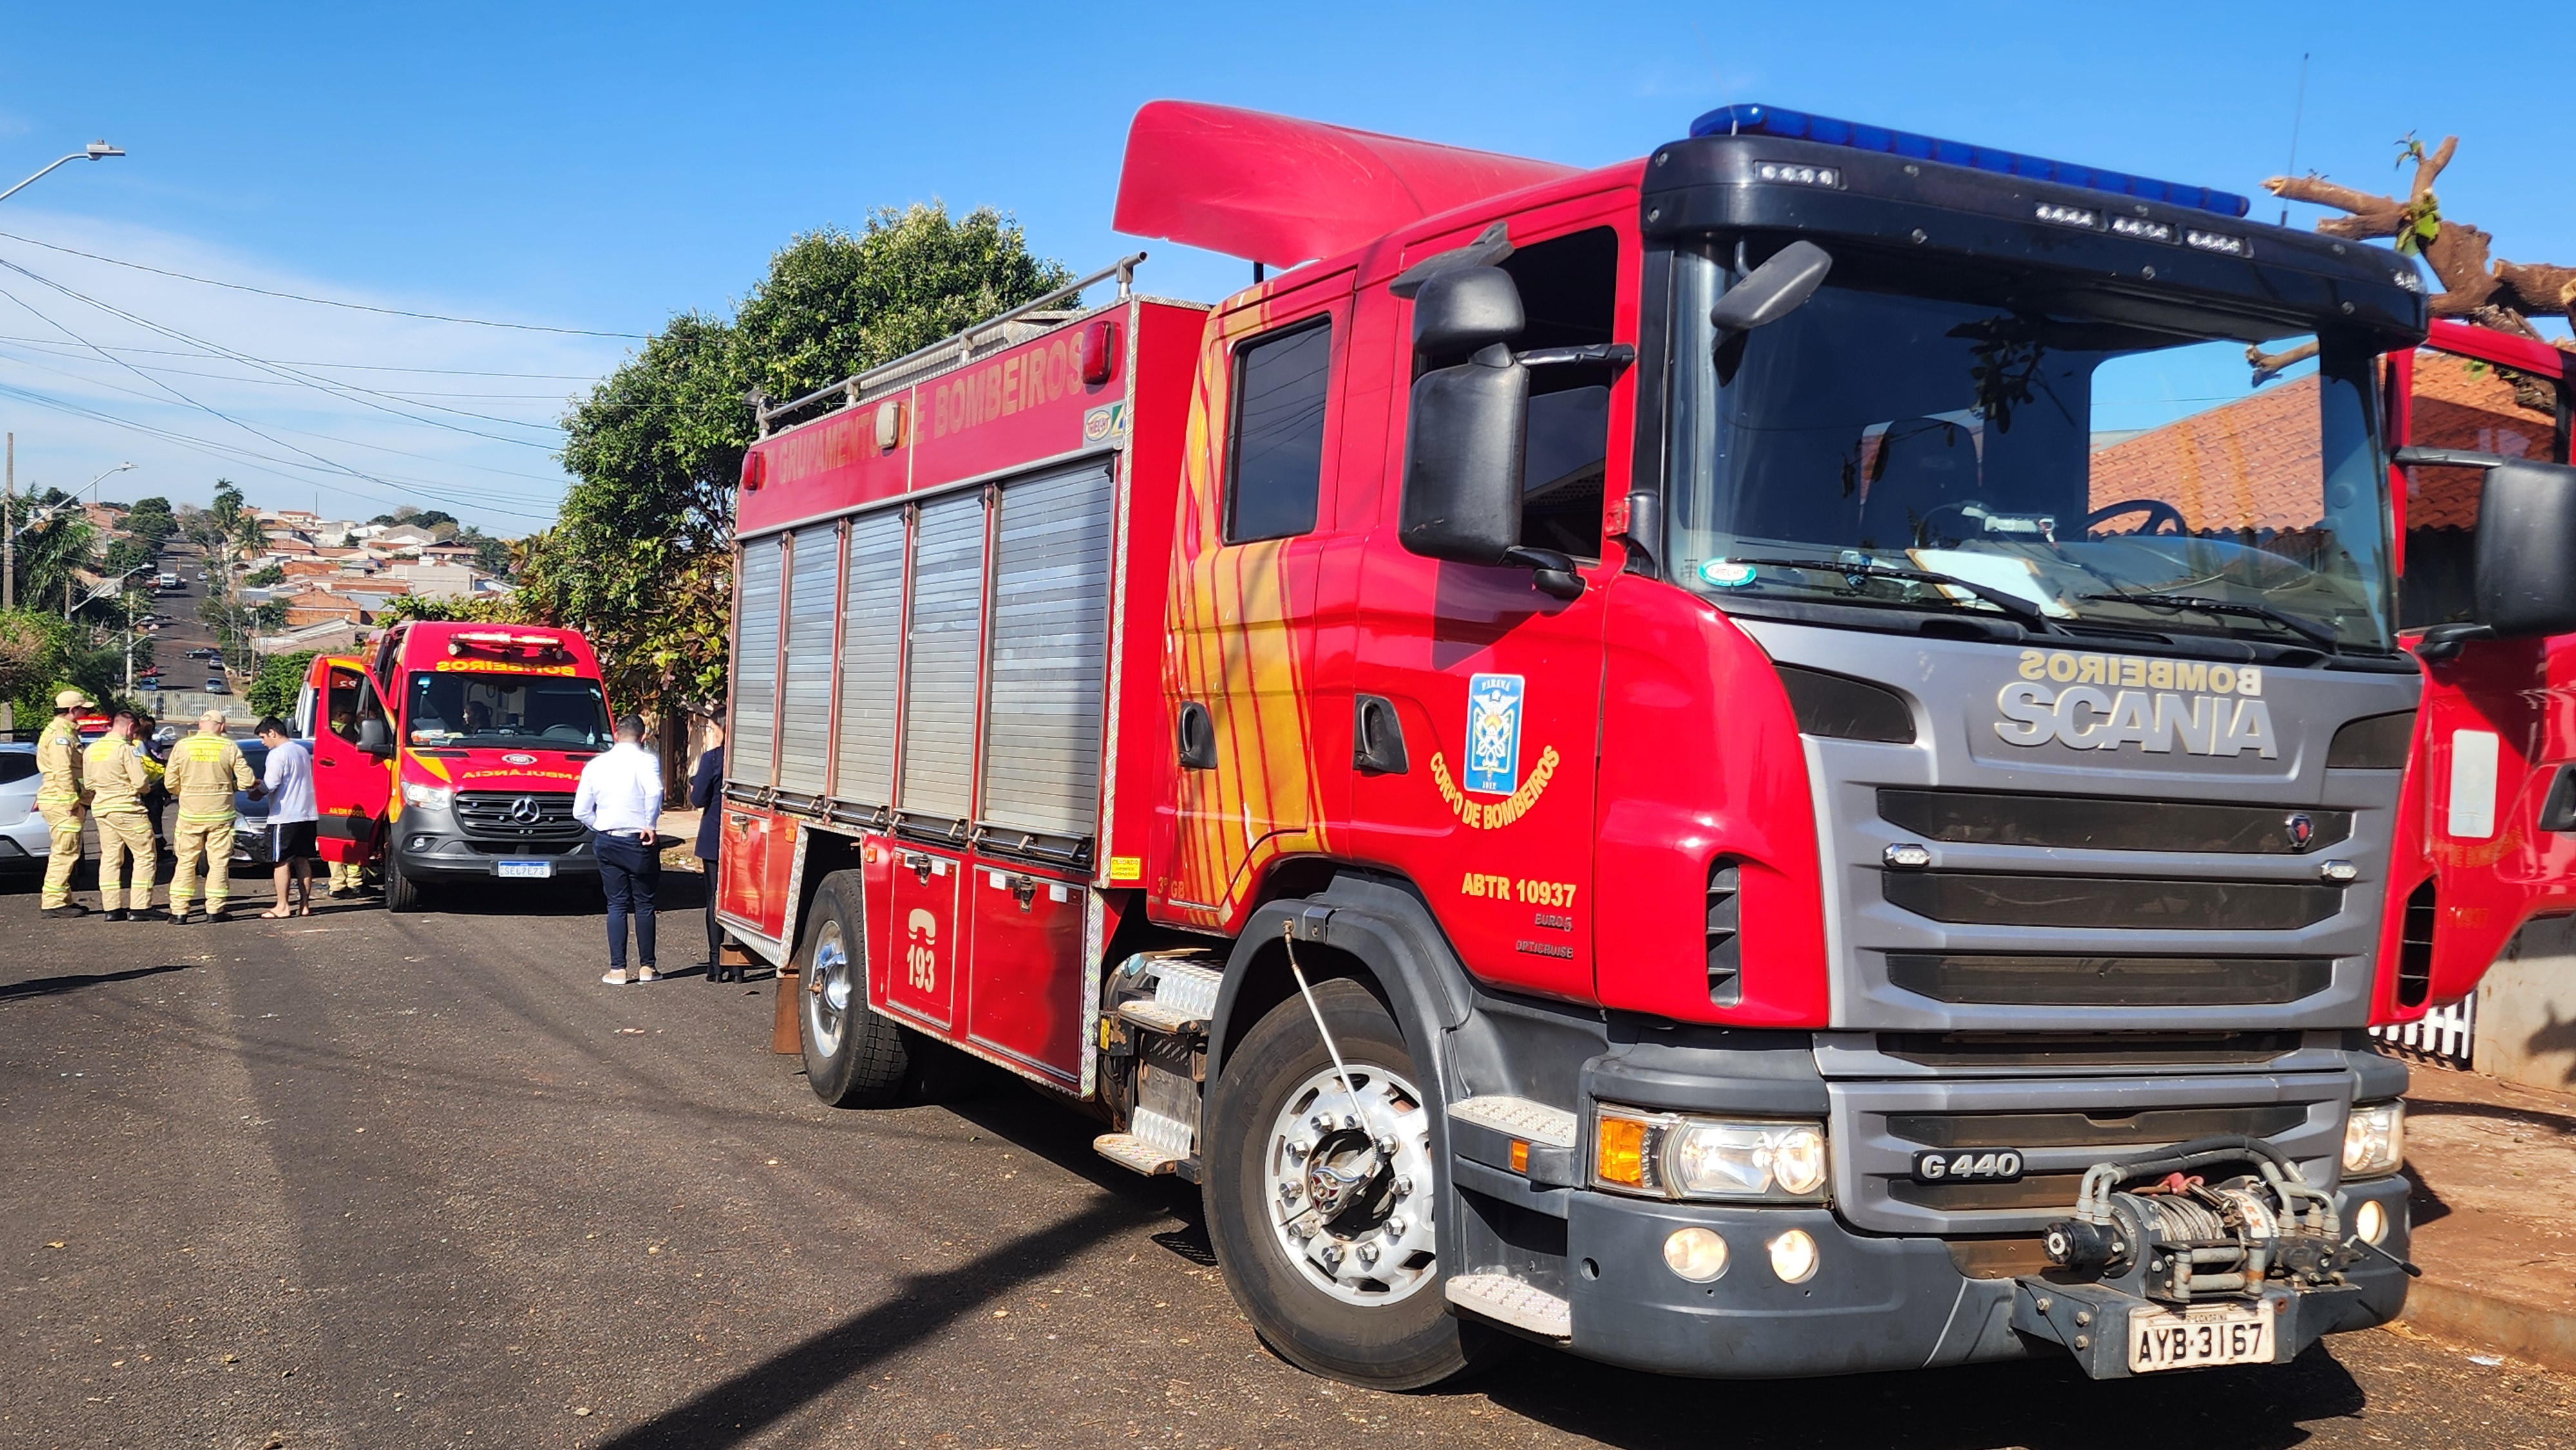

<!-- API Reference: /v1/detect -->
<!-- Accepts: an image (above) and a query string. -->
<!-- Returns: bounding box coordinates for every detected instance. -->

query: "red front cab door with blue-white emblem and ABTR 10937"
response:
[1350,219,1638,999]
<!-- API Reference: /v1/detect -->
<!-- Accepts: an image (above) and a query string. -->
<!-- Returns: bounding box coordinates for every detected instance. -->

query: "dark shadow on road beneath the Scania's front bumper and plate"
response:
[1484,1347,2367,1450]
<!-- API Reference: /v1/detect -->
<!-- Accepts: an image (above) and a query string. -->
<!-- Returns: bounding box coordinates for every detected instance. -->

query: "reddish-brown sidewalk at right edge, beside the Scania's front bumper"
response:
[2403,1061,2576,1370]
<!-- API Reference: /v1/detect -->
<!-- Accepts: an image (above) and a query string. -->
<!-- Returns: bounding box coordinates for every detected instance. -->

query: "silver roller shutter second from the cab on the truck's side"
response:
[896,494,984,822]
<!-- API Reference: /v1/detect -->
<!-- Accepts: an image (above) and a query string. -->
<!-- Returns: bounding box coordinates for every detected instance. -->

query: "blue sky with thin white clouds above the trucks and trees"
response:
[0,0,2576,533]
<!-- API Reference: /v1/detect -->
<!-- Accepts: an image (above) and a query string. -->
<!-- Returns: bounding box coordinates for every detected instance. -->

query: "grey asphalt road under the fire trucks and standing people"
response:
[0,876,2576,1450]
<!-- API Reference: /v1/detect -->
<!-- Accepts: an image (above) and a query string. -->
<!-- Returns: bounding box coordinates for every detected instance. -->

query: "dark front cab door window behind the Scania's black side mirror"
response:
[1502,227,1618,559]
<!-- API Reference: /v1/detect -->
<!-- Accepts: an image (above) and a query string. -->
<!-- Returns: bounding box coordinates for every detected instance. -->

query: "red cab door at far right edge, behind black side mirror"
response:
[2388,322,2576,1004]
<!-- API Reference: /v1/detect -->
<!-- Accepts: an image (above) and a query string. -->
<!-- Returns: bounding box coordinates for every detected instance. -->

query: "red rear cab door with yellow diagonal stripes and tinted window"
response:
[1151,270,1360,927]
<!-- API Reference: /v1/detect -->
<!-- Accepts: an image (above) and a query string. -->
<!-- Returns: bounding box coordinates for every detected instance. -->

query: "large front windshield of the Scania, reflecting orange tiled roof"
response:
[1669,252,2393,652]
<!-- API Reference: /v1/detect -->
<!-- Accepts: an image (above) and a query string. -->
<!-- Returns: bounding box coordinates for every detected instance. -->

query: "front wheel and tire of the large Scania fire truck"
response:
[1206,979,1502,1391]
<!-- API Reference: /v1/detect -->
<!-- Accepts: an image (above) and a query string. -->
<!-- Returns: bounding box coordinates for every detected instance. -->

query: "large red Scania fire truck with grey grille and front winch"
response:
[719,103,2576,1386]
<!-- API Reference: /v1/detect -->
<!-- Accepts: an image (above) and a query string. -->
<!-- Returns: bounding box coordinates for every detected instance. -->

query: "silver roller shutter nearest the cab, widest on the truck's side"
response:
[981,461,1110,837]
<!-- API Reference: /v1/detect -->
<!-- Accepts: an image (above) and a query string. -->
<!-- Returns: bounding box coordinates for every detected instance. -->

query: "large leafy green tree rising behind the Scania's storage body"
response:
[538,206,1072,719]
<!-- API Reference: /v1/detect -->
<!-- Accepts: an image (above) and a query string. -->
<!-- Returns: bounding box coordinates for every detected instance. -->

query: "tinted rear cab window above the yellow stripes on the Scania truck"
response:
[1226,319,1332,543]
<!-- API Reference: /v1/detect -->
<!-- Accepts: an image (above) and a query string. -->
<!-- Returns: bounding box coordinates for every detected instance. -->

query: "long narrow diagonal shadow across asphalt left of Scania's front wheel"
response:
[600,1200,1154,1450]
